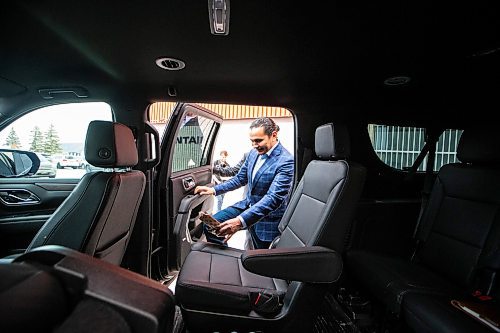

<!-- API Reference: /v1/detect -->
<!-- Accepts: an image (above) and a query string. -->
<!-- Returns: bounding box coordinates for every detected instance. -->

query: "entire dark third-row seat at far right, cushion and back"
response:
[346,129,500,332]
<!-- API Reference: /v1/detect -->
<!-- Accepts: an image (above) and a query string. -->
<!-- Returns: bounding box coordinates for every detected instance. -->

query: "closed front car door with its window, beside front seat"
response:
[0,103,113,257]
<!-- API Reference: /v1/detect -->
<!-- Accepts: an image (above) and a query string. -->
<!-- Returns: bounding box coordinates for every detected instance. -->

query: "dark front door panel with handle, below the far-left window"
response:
[0,178,80,257]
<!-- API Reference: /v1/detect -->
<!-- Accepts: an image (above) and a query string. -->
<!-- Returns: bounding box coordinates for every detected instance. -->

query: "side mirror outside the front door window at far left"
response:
[0,149,40,178]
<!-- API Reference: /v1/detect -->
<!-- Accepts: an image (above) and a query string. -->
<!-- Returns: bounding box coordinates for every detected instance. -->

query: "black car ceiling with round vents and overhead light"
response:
[0,0,500,119]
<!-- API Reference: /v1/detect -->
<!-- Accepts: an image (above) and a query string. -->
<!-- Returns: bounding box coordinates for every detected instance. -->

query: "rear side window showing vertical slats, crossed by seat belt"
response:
[368,124,462,171]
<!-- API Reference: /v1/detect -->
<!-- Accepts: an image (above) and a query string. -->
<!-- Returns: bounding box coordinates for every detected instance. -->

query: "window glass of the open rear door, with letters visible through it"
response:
[172,112,217,172]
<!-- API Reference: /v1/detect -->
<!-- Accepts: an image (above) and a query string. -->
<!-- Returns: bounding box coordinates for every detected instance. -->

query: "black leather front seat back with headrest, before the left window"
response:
[22,121,146,264]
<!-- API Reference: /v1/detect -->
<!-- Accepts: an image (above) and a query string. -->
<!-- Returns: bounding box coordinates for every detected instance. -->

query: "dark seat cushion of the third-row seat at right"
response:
[346,251,457,314]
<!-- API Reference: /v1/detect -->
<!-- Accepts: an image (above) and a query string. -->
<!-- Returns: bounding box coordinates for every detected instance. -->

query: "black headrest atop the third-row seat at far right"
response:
[457,128,500,163]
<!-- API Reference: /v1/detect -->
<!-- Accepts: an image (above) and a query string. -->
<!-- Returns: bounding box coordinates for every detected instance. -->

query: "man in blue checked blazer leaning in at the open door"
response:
[194,117,294,248]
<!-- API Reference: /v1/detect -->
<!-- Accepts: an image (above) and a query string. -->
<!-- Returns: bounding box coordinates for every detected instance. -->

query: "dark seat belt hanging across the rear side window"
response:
[407,129,444,261]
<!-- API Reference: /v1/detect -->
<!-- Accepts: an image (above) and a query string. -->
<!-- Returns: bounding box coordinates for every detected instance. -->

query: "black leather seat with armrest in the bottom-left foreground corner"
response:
[0,245,175,333]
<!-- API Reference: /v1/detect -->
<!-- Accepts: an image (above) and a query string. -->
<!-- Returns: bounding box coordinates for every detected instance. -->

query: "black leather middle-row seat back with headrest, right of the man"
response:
[274,123,366,253]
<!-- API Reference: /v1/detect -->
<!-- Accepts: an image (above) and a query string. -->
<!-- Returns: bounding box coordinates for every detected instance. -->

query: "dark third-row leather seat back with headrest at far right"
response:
[416,128,500,287]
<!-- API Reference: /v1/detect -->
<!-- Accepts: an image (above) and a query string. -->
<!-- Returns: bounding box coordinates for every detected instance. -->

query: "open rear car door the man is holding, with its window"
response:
[149,103,222,279]
